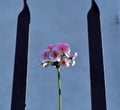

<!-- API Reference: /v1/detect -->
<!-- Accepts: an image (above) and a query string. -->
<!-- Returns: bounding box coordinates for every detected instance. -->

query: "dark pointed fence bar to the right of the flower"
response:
[87,0,107,110]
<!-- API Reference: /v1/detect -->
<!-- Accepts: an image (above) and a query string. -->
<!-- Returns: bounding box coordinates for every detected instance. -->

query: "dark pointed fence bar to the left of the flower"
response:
[11,0,30,110]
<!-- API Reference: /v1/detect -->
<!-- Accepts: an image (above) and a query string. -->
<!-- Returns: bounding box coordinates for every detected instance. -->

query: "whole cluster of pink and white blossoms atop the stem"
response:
[40,43,77,67]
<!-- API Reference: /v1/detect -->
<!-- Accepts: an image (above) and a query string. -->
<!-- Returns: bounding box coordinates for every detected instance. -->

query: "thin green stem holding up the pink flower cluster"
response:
[57,67,62,110]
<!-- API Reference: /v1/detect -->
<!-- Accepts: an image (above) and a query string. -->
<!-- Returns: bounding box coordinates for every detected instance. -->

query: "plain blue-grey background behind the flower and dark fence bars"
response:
[0,0,120,110]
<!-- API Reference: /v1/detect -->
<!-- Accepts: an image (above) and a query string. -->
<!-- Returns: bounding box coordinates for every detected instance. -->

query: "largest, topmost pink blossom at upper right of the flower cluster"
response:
[55,43,70,57]
